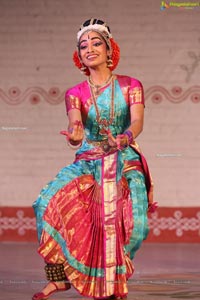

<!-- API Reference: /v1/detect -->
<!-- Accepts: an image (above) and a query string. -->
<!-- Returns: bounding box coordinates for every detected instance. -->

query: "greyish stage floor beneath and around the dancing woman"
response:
[0,243,200,300]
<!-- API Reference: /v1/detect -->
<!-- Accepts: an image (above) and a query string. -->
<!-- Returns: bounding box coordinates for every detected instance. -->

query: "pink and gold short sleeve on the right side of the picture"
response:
[129,78,144,106]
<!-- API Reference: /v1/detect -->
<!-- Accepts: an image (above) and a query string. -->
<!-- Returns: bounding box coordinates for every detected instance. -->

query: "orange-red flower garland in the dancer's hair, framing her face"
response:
[73,38,120,76]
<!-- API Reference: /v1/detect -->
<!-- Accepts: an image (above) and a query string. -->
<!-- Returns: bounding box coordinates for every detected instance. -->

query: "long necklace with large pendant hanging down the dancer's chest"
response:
[90,76,115,135]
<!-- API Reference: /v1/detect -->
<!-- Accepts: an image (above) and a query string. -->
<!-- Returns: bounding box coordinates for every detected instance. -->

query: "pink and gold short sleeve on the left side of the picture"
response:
[65,87,81,113]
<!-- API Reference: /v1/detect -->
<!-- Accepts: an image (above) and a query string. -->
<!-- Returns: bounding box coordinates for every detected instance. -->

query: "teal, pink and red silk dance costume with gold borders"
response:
[33,75,155,298]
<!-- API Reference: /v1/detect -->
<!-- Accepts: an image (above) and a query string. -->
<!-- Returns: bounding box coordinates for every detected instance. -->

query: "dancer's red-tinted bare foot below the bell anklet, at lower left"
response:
[32,281,71,300]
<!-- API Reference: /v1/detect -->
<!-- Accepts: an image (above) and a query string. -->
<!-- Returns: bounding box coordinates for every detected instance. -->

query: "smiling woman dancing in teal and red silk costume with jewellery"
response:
[32,19,155,300]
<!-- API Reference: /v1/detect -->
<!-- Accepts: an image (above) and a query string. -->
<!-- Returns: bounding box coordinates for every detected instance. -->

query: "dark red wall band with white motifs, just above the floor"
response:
[0,207,200,243]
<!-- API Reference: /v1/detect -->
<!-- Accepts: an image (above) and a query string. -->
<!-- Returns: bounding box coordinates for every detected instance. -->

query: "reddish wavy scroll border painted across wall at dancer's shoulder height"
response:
[0,85,200,105]
